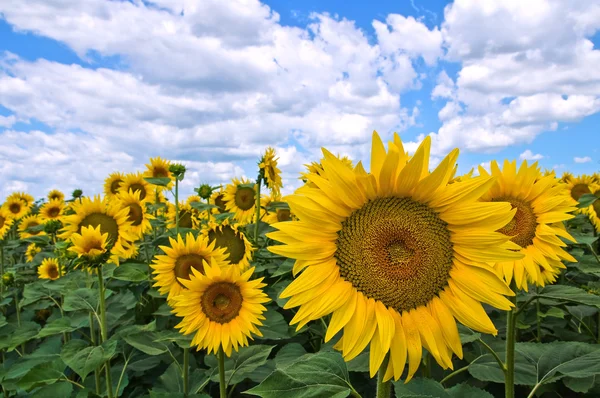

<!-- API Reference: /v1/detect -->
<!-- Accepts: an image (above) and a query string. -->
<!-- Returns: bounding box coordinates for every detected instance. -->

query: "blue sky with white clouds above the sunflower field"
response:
[0,0,600,201]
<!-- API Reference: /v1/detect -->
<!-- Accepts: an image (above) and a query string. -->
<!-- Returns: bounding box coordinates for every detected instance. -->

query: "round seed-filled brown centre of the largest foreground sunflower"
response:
[335,197,454,311]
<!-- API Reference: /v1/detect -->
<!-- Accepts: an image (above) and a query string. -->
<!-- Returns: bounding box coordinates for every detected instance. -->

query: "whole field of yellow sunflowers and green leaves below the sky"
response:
[0,132,600,398]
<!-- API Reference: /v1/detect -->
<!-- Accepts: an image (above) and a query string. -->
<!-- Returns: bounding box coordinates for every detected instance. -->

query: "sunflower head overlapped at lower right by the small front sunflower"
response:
[150,233,228,301]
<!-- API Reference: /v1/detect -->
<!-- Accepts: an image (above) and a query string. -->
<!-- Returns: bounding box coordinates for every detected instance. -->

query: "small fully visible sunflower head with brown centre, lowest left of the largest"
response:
[173,258,270,356]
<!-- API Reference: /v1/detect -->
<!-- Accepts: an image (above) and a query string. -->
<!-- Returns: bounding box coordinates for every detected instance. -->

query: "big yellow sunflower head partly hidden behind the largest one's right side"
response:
[479,160,576,290]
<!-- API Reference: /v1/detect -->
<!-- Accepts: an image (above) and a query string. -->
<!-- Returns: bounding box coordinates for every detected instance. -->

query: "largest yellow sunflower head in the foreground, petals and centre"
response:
[267,132,522,381]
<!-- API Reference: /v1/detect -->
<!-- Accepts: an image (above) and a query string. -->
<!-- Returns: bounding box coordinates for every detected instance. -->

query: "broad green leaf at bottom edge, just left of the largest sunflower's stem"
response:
[245,351,352,398]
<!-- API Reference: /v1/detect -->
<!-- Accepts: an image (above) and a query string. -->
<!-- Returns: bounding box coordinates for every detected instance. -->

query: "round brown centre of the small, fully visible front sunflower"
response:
[200,282,243,324]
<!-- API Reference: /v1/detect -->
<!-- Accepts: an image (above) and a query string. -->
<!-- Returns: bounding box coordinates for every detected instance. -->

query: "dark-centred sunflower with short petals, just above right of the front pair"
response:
[202,220,254,270]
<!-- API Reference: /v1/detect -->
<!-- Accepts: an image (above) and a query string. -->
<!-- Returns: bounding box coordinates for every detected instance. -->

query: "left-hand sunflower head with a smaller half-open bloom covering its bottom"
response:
[59,195,137,265]
